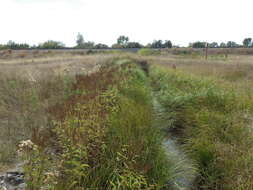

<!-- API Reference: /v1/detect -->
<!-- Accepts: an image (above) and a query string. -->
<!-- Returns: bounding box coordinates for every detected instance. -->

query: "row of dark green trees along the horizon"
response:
[0,33,253,49]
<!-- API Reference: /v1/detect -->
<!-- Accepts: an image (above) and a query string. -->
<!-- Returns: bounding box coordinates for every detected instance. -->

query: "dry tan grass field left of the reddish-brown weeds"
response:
[0,55,120,171]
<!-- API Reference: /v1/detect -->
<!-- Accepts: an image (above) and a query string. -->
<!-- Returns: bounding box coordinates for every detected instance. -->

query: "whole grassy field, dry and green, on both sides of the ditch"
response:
[0,50,253,190]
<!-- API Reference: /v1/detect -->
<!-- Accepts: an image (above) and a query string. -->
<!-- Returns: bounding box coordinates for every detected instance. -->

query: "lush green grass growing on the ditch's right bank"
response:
[150,66,253,190]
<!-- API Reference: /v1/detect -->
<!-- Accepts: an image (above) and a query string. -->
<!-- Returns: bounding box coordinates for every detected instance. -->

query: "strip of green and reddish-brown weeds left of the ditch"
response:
[25,60,170,190]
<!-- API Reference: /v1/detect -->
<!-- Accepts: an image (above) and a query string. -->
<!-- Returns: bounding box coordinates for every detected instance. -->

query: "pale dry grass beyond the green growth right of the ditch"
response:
[149,55,253,96]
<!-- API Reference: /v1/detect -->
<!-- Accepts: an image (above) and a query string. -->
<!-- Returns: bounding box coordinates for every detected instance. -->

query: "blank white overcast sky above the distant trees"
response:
[0,0,253,46]
